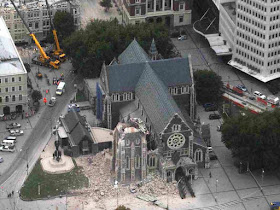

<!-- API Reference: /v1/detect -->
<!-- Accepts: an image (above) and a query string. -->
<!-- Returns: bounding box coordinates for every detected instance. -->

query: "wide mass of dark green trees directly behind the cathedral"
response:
[63,19,173,77]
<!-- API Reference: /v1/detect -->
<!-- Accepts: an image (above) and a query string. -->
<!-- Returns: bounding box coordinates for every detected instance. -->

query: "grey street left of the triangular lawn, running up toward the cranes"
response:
[0,54,78,210]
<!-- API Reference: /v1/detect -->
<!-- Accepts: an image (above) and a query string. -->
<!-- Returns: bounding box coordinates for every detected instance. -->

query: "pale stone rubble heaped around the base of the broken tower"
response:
[75,150,178,203]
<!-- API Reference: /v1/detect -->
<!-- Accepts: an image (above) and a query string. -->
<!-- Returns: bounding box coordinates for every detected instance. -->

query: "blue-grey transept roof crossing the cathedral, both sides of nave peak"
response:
[107,58,192,93]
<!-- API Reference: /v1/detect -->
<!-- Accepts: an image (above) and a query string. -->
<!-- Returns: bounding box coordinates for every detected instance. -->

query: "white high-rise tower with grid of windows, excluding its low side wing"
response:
[230,0,280,82]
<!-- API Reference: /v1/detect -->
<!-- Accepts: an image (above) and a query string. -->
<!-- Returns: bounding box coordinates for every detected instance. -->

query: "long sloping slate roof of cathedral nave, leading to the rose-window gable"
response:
[135,63,187,133]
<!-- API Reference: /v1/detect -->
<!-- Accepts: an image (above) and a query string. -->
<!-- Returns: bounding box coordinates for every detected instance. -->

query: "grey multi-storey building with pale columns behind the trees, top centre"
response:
[118,0,193,27]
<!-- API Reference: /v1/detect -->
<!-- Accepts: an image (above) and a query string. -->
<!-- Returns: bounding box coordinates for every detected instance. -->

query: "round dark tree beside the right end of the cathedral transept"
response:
[194,70,223,104]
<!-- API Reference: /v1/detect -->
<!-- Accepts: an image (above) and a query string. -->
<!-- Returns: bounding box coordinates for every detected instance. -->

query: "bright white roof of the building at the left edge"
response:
[0,17,27,76]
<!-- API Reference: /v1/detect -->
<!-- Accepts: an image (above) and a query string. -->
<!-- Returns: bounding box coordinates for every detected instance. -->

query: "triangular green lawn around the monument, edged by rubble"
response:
[21,160,89,200]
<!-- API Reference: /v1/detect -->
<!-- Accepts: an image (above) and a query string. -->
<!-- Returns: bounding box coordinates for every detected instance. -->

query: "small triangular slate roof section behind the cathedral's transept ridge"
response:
[118,39,150,64]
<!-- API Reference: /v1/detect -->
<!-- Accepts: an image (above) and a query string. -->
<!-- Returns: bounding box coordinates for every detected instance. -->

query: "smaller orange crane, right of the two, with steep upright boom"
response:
[46,0,66,62]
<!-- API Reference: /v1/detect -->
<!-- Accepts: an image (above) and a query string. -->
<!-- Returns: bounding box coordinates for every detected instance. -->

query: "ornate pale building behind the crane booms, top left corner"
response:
[0,0,81,43]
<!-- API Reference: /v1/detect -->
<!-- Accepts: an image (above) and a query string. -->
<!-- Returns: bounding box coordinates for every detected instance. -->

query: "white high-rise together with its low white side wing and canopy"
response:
[196,0,280,82]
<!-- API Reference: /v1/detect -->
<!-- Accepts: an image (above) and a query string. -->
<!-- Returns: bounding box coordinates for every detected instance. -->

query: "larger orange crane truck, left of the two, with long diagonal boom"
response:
[11,0,60,69]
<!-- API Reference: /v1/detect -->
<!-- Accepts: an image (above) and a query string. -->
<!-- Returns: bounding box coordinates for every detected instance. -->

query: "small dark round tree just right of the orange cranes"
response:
[51,11,76,42]
